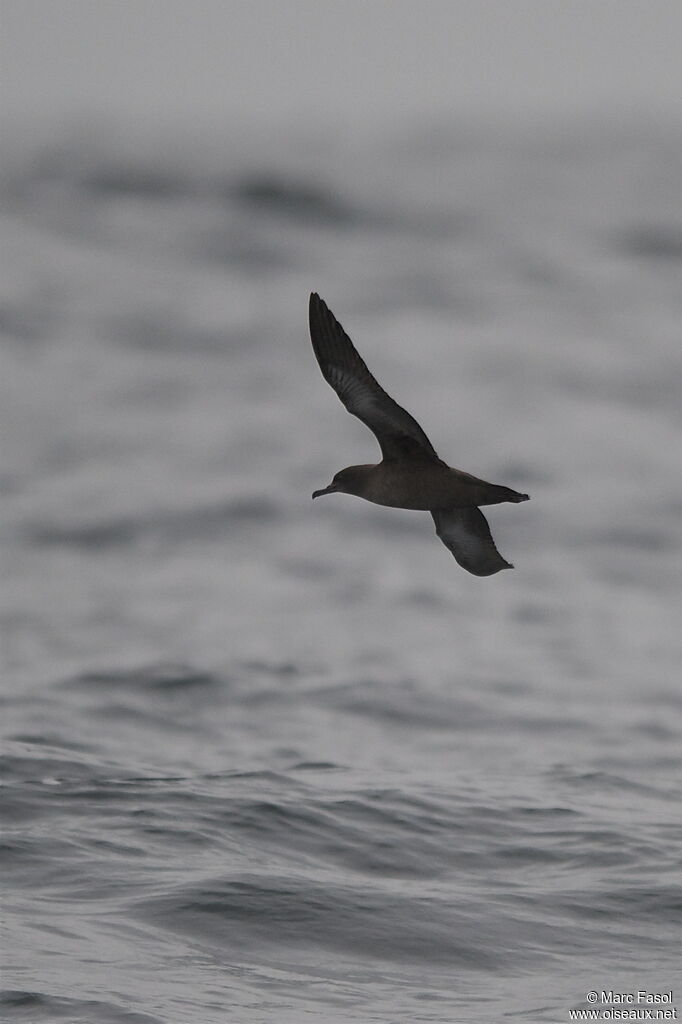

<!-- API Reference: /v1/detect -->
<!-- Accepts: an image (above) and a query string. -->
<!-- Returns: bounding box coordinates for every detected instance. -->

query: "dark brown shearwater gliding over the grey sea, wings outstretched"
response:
[309,292,528,577]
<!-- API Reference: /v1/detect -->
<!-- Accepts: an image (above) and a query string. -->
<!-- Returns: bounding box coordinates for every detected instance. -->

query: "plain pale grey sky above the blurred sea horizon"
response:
[0,0,682,125]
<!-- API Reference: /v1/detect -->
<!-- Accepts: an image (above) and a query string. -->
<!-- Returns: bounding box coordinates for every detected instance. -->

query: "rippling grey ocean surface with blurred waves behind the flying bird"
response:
[0,119,682,1024]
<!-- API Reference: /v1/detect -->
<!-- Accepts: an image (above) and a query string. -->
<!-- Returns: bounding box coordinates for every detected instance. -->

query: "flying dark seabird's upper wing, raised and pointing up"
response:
[309,292,438,462]
